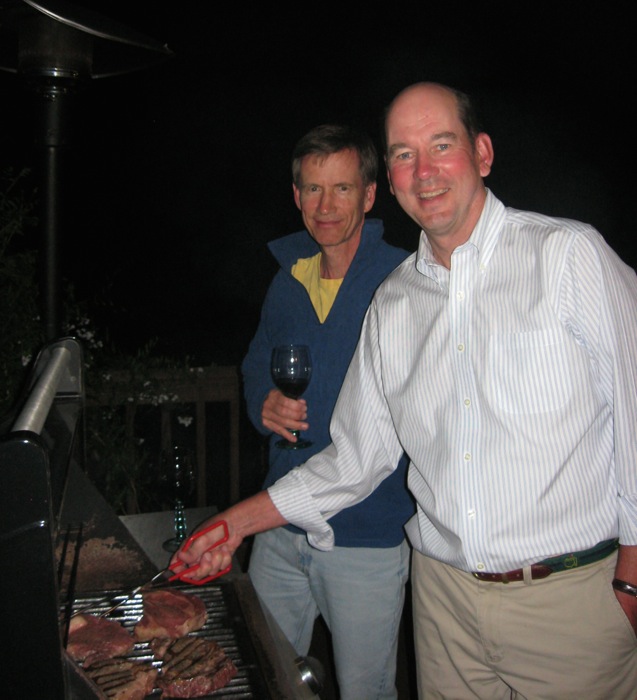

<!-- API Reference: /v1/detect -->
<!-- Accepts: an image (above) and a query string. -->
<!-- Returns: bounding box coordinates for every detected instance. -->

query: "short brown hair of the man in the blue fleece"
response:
[292,124,378,187]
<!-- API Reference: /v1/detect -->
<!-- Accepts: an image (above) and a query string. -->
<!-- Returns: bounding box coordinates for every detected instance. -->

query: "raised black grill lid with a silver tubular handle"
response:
[0,339,84,699]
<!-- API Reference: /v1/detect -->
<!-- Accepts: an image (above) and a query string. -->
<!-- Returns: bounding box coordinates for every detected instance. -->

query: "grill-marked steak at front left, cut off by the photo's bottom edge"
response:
[84,659,158,700]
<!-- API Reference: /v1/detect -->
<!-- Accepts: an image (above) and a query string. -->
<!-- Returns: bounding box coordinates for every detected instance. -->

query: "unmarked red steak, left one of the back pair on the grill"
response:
[66,615,135,668]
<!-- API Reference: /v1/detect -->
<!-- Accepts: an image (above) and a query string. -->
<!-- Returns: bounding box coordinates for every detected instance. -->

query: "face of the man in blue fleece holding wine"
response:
[292,149,376,253]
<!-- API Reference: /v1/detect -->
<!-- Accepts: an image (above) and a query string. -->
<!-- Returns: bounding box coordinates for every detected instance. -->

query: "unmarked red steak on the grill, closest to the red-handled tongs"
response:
[134,588,208,642]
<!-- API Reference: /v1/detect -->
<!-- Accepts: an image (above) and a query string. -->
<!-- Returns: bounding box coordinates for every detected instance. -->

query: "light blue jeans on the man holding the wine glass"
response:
[249,528,410,700]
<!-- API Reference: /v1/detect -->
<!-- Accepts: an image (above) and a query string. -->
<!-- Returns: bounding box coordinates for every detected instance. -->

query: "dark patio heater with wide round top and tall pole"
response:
[0,0,172,340]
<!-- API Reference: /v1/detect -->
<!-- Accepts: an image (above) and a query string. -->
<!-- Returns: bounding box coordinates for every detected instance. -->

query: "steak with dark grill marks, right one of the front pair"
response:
[150,635,237,698]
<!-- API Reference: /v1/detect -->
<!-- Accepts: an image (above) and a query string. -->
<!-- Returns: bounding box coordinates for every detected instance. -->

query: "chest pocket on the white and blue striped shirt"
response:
[487,330,573,415]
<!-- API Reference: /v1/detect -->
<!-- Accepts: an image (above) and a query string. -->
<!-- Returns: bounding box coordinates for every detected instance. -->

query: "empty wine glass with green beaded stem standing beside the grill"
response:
[160,445,197,552]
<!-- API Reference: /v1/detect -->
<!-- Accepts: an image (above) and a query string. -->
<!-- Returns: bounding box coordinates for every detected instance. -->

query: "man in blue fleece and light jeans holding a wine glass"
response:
[242,125,414,700]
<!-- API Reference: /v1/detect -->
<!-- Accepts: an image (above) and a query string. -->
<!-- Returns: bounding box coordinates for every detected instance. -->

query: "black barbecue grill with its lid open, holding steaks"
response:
[0,338,319,700]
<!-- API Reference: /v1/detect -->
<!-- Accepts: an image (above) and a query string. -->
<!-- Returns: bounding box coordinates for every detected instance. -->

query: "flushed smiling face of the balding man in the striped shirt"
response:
[385,84,493,250]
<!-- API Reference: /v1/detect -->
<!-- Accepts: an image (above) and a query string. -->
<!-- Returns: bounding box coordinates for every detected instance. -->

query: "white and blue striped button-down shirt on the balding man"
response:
[269,192,637,571]
